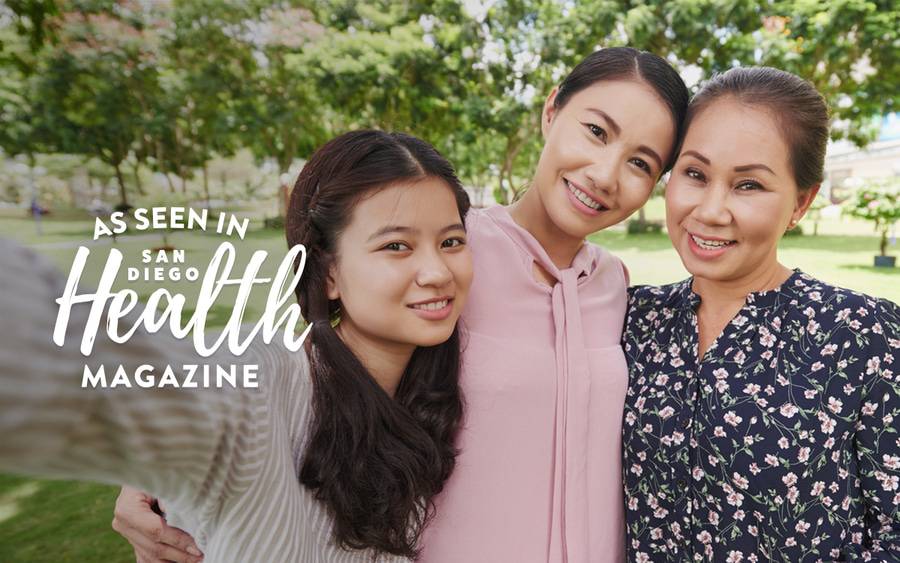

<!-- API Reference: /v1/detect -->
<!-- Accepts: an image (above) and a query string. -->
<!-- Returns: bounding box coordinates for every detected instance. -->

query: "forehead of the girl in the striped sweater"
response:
[345,177,459,232]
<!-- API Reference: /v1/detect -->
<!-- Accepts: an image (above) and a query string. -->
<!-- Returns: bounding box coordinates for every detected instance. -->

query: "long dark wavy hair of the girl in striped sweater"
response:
[286,131,469,557]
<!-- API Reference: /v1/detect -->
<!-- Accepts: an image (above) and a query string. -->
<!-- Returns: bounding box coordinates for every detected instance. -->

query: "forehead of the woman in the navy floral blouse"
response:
[682,98,789,172]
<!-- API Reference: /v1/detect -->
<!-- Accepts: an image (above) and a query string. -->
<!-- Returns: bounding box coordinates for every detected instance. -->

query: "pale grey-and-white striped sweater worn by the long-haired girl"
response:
[0,240,402,563]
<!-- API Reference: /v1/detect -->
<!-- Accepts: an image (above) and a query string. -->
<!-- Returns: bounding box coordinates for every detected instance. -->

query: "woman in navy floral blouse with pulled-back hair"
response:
[623,68,900,563]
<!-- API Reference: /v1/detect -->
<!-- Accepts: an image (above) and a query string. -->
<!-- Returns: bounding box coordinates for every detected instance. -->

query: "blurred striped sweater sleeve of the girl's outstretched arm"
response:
[0,239,266,524]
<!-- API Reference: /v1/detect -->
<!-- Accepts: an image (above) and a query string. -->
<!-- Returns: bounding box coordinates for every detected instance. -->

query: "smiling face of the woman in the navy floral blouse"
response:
[666,98,817,282]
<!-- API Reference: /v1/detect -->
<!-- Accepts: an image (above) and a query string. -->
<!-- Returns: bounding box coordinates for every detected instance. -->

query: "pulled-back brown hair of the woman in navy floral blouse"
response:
[685,66,828,191]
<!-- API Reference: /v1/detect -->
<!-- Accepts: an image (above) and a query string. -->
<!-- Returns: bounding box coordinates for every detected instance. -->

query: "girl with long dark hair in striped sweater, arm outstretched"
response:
[0,131,472,562]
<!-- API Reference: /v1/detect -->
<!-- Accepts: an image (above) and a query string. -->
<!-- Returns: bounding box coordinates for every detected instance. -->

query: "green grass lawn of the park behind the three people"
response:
[0,209,900,563]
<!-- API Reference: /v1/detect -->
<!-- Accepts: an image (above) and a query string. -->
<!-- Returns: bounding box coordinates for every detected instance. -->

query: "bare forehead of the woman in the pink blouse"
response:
[562,80,675,151]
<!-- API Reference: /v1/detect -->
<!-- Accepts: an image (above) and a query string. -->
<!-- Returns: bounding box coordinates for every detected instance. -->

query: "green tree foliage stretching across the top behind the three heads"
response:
[0,0,900,212]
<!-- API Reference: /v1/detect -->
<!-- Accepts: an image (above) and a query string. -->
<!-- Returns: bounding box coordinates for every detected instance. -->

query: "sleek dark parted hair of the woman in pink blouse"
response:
[553,47,690,172]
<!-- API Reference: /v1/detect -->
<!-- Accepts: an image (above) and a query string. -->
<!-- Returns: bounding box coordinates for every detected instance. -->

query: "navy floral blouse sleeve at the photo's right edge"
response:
[846,301,900,563]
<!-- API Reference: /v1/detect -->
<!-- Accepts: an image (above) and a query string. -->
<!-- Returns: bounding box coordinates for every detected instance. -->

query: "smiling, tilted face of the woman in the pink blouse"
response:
[534,80,675,239]
